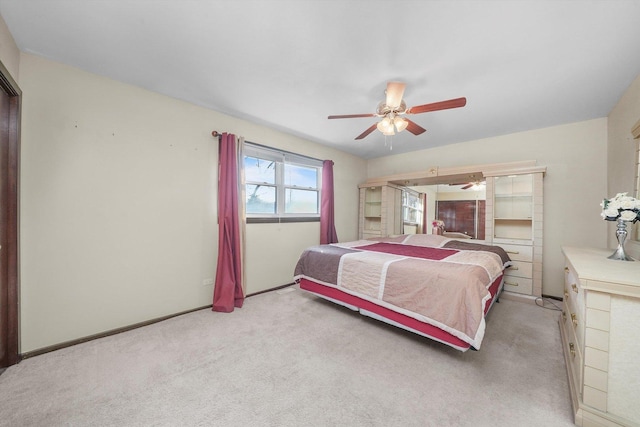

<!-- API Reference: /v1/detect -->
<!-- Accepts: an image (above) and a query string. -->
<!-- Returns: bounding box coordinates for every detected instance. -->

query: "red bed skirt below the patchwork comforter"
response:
[299,276,502,351]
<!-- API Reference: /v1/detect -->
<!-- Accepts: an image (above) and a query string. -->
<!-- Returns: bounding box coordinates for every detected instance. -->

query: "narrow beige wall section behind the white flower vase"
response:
[607,75,640,259]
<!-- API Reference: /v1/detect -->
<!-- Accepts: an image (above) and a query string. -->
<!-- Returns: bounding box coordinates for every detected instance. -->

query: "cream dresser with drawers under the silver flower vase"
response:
[560,247,640,426]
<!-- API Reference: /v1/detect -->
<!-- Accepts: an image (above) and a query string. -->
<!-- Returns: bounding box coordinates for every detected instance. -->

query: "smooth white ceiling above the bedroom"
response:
[0,0,640,158]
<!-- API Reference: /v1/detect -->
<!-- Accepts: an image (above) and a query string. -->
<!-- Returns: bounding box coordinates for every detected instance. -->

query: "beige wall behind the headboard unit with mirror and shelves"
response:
[367,118,607,297]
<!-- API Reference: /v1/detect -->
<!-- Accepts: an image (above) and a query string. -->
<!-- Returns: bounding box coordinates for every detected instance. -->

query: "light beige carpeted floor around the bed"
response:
[0,287,573,427]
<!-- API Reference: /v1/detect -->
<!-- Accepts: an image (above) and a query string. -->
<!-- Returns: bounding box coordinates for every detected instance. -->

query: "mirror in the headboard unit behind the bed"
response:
[410,181,486,240]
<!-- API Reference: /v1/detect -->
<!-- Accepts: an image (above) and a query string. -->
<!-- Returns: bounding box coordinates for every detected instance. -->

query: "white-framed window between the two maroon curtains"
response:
[244,143,322,222]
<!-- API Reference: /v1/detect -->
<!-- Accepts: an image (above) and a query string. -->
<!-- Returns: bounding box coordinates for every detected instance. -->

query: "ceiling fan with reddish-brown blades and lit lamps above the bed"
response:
[328,82,467,139]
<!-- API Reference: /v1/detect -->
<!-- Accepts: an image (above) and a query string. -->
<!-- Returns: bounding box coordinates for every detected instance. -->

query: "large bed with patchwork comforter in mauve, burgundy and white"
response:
[294,234,511,351]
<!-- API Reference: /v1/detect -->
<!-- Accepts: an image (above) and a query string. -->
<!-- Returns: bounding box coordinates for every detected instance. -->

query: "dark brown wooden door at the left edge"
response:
[0,63,20,369]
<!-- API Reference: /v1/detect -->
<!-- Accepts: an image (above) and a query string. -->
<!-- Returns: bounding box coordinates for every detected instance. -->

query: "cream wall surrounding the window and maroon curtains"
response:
[20,54,366,352]
